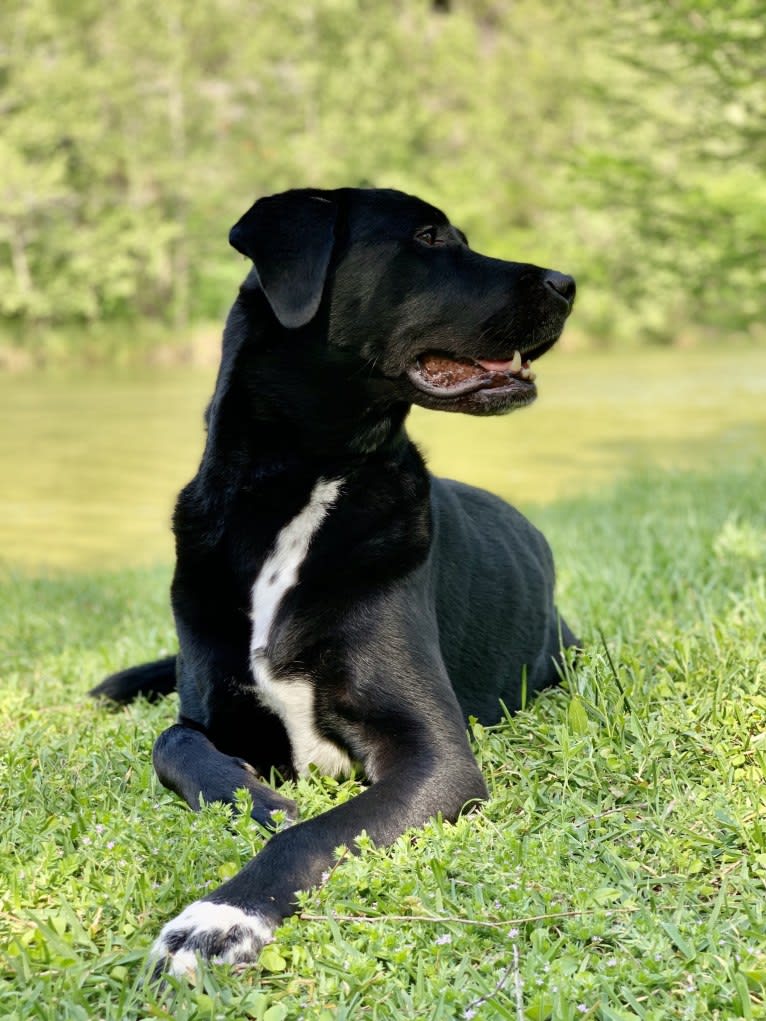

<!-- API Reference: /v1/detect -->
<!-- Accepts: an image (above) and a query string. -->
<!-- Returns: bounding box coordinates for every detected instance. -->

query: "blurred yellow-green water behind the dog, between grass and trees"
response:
[0,349,766,571]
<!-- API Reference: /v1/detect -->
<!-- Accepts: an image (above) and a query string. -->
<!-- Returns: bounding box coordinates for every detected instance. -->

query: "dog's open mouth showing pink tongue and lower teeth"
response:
[409,351,536,398]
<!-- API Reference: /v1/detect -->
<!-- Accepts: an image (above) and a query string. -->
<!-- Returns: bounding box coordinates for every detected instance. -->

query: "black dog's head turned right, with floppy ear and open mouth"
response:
[230,189,575,415]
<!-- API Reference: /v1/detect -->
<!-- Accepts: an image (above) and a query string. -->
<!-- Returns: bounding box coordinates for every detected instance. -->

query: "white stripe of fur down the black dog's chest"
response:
[250,479,350,776]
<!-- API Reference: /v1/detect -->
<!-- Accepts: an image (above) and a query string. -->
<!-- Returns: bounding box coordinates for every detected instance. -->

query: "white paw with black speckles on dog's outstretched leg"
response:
[151,901,274,979]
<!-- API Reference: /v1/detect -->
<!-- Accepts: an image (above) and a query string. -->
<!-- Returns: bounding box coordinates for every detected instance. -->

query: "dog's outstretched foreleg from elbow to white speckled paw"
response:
[152,691,486,975]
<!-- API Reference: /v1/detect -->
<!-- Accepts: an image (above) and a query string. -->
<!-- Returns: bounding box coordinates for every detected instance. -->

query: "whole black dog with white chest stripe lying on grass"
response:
[89,189,575,974]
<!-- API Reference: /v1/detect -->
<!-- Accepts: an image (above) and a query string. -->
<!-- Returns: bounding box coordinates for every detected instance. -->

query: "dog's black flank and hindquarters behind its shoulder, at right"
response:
[431,479,576,723]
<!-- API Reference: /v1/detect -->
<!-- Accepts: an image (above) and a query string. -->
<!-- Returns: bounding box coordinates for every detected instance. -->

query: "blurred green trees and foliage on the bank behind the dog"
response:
[0,0,766,349]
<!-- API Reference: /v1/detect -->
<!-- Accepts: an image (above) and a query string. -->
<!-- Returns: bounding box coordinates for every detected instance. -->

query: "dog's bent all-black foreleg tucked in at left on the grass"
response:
[152,723,297,826]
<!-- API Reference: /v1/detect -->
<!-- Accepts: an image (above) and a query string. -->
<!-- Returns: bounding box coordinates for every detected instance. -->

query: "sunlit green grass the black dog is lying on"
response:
[0,465,766,1021]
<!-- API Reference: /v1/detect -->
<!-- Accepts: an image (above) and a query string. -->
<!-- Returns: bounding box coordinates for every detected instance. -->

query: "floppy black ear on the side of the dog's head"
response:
[229,191,337,330]
